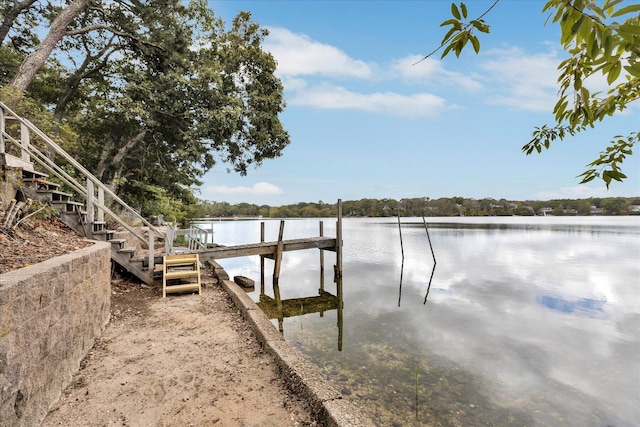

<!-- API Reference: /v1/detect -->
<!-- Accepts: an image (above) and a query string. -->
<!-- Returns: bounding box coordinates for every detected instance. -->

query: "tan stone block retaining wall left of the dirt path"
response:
[0,242,111,426]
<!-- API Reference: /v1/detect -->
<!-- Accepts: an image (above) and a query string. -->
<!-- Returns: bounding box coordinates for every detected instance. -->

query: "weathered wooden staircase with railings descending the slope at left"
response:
[0,103,172,284]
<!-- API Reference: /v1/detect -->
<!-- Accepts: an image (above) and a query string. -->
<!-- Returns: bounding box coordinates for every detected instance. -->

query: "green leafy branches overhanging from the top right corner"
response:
[419,0,640,188]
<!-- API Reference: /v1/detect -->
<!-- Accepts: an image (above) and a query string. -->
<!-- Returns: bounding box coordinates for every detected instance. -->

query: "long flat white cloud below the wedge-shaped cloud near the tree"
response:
[288,84,446,117]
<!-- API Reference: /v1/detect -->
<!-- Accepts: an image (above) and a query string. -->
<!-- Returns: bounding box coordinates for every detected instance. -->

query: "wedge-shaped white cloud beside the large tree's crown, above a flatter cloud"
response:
[264,27,374,79]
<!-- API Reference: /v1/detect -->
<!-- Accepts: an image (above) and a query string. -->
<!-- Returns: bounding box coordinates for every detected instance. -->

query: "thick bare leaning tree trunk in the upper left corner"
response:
[9,0,91,92]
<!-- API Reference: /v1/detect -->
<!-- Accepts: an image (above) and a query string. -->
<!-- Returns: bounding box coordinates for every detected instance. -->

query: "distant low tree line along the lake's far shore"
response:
[185,197,640,219]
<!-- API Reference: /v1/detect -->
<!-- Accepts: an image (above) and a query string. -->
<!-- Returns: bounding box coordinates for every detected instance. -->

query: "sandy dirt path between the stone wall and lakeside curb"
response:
[43,281,316,427]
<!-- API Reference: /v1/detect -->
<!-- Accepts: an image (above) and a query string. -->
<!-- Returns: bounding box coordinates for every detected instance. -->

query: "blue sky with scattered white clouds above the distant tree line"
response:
[199,0,640,206]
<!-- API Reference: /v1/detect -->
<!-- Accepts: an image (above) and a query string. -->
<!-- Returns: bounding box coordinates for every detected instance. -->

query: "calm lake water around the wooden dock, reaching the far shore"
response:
[202,217,640,427]
